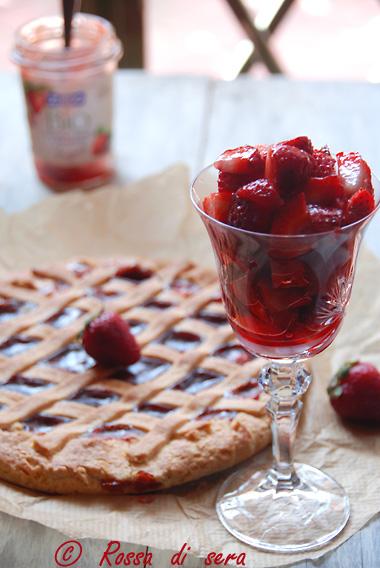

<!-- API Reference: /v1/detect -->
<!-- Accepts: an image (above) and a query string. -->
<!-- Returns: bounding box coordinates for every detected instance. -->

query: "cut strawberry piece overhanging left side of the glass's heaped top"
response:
[214,146,265,175]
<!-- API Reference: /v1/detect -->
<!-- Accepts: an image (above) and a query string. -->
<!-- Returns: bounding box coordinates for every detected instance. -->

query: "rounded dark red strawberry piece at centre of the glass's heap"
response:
[265,144,312,195]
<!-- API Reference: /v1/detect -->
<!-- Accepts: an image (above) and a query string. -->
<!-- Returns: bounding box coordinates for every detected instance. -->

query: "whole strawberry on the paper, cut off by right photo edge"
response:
[327,361,380,424]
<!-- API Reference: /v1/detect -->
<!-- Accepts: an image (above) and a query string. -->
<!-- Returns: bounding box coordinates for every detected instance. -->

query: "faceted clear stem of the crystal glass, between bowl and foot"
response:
[260,362,311,490]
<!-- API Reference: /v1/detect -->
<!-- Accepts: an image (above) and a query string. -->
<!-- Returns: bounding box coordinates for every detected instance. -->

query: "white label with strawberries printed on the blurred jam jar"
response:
[23,74,112,166]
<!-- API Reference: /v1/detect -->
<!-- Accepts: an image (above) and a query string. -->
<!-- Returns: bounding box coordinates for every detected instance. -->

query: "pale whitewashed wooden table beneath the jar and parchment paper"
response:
[0,71,380,568]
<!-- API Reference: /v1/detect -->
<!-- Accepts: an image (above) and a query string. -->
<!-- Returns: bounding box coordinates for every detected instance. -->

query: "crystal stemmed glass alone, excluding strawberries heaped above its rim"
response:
[191,166,378,552]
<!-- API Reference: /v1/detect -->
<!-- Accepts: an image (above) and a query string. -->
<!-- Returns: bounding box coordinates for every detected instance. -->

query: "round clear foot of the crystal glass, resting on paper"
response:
[216,463,350,552]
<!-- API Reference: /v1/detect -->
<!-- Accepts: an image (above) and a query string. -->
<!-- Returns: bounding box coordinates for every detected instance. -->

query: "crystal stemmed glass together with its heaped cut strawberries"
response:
[191,136,378,552]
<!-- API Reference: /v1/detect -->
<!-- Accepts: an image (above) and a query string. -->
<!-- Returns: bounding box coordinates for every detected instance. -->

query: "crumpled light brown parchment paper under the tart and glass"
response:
[0,165,380,568]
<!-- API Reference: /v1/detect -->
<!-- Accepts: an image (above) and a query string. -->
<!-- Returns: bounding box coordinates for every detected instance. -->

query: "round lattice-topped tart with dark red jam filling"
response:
[0,258,270,493]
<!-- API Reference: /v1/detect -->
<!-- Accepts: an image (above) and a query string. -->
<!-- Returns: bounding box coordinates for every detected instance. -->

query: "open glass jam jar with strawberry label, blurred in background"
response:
[11,14,122,190]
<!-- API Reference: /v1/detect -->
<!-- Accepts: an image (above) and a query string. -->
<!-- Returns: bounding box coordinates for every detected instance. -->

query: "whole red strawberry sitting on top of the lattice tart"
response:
[82,312,140,366]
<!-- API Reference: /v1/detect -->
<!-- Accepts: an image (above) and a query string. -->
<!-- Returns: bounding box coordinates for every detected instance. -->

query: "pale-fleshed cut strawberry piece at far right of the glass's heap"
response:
[336,152,374,197]
